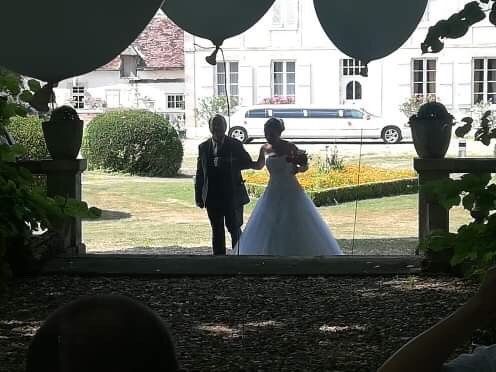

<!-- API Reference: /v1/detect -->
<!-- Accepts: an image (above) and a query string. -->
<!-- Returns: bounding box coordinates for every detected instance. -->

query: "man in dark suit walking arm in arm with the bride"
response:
[195,115,255,255]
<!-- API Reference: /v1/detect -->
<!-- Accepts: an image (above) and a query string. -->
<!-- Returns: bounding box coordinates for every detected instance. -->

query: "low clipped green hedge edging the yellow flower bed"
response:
[246,178,418,207]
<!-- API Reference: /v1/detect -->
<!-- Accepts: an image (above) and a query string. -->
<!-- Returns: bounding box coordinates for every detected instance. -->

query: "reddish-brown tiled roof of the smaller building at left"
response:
[99,10,184,70]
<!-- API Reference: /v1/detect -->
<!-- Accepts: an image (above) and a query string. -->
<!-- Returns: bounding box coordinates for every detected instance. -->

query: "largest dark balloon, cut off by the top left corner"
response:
[0,0,163,83]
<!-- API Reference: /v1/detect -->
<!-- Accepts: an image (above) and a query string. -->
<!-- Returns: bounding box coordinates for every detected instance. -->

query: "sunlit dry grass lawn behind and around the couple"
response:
[83,172,469,254]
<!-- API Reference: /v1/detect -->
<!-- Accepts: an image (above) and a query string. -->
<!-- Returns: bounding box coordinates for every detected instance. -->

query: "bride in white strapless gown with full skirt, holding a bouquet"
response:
[234,118,342,256]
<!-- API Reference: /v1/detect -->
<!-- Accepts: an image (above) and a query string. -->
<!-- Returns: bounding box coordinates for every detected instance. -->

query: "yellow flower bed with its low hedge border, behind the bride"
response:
[245,166,418,206]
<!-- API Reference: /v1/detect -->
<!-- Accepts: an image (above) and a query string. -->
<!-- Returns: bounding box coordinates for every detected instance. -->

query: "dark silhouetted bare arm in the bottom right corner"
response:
[378,267,496,372]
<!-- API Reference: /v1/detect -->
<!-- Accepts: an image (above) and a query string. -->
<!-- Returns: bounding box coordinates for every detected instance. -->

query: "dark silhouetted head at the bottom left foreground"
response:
[26,296,179,372]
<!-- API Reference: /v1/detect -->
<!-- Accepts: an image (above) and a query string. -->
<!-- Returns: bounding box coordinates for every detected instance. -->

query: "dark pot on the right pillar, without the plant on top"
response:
[410,118,452,159]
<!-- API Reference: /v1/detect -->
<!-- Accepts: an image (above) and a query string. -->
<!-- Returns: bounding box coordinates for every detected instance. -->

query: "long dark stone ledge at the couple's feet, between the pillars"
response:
[43,254,421,276]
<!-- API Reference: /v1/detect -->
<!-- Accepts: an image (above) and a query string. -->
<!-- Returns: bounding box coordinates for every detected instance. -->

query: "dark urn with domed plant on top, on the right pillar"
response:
[409,102,454,158]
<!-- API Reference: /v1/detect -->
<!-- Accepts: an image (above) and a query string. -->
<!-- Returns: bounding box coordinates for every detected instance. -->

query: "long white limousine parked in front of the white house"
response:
[229,105,411,143]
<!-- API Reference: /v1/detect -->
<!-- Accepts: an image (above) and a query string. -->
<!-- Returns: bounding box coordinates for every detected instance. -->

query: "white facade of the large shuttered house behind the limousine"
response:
[185,0,496,127]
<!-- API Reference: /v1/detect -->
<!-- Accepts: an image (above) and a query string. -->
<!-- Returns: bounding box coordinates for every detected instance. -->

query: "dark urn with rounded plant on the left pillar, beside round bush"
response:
[42,106,83,160]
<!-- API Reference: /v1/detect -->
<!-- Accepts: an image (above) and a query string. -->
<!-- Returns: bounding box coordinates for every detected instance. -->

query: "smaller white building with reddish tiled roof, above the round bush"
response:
[55,10,184,126]
